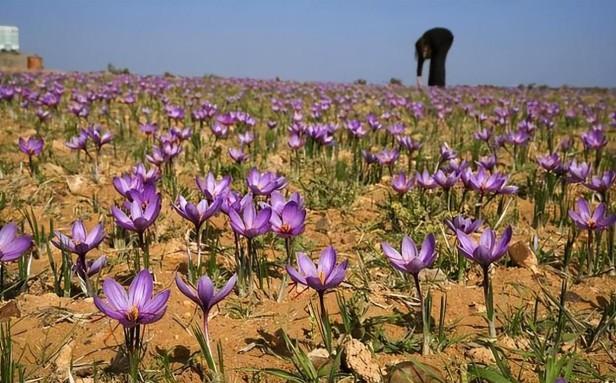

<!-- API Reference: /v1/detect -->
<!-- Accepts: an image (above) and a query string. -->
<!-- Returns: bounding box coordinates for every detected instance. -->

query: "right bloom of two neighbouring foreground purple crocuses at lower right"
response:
[456,226,513,268]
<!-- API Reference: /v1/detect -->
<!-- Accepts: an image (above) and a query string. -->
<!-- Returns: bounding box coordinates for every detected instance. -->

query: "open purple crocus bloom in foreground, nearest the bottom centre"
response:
[287,246,349,294]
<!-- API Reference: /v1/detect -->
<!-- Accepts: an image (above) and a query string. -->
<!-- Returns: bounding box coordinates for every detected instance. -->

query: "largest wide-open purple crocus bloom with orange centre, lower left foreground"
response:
[94,270,170,328]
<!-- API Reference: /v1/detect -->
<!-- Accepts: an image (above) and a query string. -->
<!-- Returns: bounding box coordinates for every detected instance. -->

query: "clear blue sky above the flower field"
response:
[0,0,616,87]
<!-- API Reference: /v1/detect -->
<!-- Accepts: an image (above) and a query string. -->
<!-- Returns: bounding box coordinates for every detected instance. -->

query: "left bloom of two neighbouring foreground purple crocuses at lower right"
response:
[381,234,436,277]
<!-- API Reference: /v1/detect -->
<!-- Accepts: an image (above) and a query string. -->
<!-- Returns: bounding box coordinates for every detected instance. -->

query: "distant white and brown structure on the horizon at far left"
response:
[0,25,43,71]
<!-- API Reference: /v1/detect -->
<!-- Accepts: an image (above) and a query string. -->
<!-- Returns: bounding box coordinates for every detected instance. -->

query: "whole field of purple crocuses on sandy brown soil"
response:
[0,73,616,383]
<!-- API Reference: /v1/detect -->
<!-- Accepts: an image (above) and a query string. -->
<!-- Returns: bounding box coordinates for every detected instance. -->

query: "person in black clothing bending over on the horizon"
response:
[415,28,453,86]
